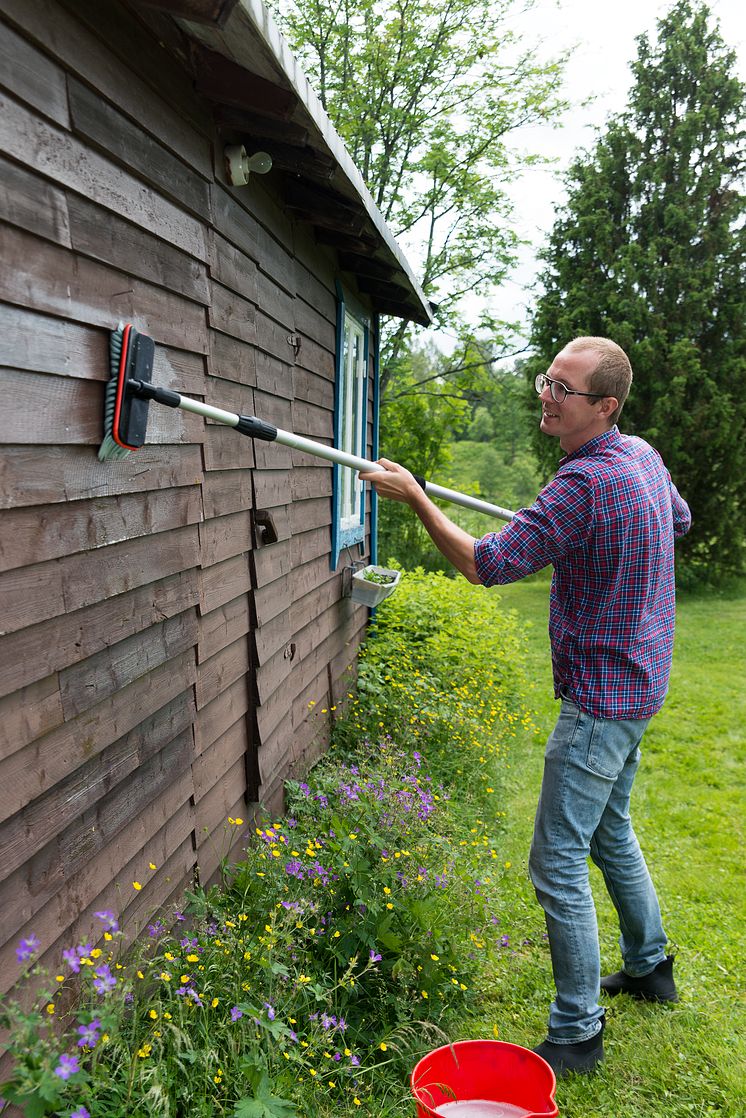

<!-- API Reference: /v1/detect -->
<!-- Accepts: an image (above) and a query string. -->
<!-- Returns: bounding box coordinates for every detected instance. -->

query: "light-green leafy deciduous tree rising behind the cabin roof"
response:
[275,0,564,380]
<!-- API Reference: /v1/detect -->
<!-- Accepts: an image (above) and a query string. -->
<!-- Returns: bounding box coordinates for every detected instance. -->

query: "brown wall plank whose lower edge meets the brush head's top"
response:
[0,221,207,352]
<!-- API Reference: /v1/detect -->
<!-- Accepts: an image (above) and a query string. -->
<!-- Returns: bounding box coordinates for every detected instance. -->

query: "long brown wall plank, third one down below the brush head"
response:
[0,528,200,635]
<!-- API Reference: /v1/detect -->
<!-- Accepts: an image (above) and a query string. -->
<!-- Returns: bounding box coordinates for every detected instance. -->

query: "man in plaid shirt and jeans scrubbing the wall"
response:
[360,338,691,1076]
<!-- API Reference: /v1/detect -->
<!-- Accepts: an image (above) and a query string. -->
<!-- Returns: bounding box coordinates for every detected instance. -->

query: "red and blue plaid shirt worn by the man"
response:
[474,427,691,719]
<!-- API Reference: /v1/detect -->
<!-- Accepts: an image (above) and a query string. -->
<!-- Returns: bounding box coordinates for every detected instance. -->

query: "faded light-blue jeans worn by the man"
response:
[529,700,667,1044]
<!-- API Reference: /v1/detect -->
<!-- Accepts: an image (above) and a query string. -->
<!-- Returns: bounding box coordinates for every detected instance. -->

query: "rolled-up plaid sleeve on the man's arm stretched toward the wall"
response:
[474,470,594,586]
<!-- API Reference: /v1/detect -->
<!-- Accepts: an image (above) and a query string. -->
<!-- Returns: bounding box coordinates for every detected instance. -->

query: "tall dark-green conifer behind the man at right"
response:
[528,0,746,576]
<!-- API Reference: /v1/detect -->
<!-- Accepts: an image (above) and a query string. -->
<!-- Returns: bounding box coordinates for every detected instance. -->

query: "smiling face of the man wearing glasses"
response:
[539,349,610,454]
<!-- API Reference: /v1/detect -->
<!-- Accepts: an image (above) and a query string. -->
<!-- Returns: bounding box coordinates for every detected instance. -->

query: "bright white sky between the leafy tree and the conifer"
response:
[438,0,746,347]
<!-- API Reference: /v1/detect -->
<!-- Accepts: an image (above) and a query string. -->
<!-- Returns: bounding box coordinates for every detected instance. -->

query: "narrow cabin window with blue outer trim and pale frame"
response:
[331,299,368,569]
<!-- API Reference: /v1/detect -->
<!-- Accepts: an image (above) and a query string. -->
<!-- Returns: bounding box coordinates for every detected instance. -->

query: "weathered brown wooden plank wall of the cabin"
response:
[0,0,367,992]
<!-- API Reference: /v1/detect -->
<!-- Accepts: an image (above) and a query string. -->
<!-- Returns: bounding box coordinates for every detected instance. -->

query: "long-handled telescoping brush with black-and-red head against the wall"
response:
[98,325,513,520]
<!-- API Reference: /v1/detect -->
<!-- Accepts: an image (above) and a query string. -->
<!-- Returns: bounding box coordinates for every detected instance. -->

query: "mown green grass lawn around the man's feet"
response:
[464,581,746,1118]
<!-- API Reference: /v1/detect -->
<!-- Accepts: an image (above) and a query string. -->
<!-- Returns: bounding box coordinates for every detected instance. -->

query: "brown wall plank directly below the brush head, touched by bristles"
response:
[0,446,202,509]
